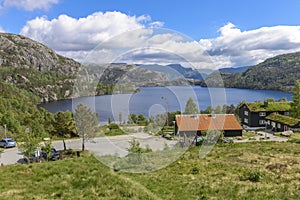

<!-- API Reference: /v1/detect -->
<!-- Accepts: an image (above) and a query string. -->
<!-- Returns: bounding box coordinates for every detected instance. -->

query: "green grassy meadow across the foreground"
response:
[0,142,300,199]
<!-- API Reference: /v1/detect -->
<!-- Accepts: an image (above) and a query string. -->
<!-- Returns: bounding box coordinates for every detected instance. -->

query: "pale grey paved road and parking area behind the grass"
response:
[0,133,176,165]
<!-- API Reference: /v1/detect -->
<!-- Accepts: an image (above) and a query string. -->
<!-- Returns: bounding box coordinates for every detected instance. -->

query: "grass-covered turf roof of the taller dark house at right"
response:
[245,102,291,112]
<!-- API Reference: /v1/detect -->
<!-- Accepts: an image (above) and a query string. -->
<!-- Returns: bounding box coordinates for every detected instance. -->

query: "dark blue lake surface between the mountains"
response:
[39,86,292,123]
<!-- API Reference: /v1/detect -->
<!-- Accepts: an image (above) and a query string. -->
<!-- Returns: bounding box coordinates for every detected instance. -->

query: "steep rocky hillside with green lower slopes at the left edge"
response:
[0,33,81,102]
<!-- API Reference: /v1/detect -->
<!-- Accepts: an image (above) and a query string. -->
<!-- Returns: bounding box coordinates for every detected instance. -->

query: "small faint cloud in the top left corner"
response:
[0,0,59,11]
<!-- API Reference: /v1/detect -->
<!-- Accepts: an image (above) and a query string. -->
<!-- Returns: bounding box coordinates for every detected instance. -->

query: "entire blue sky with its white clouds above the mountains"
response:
[0,0,300,69]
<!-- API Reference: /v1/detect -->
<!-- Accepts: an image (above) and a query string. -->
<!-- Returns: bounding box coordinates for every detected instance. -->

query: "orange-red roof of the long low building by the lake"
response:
[176,114,242,131]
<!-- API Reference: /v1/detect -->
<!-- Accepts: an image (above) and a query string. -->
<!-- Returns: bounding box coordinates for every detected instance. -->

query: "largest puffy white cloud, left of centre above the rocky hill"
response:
[21,12,209,68]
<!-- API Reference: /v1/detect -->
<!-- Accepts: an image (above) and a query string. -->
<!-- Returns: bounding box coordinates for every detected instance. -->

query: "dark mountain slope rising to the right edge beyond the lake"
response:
[205,52,300,91]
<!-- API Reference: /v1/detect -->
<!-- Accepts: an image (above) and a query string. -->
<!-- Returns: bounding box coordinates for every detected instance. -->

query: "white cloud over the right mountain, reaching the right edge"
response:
[200,23,300,67]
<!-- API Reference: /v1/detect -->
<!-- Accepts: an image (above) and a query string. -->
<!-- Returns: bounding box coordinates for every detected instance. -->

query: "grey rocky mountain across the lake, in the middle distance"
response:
[87,63,198,87]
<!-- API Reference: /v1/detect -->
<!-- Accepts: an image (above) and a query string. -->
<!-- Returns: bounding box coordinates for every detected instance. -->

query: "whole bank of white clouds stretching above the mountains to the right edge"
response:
[21,11,300,69]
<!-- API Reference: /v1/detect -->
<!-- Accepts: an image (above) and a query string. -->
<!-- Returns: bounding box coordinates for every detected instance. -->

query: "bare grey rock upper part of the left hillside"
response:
[0,33,80,75]
